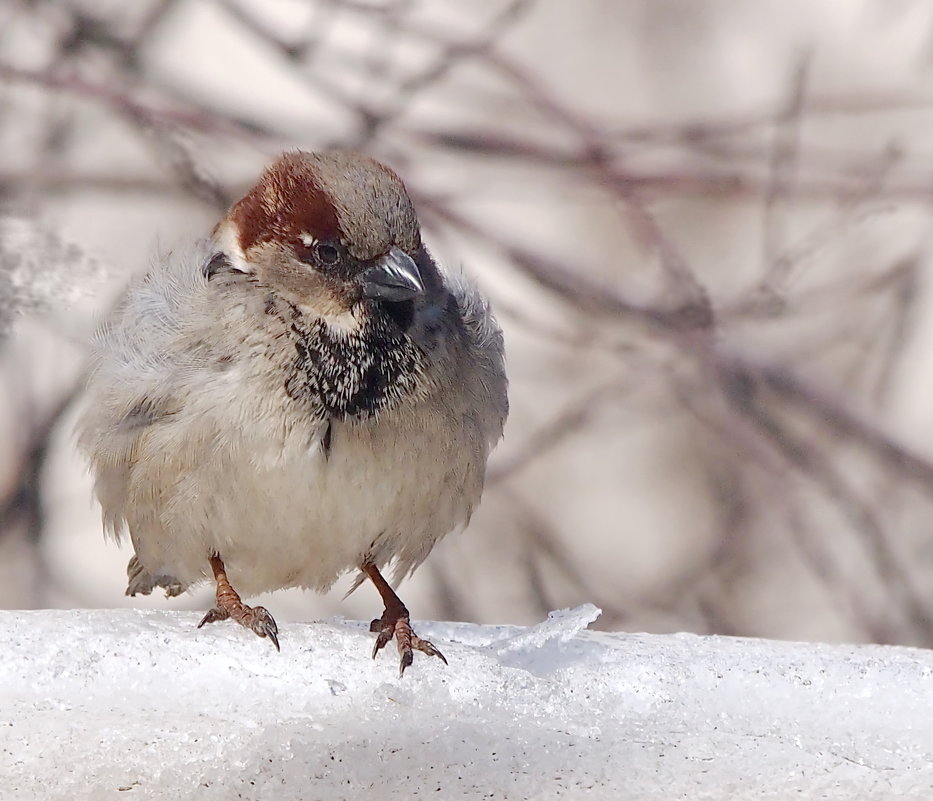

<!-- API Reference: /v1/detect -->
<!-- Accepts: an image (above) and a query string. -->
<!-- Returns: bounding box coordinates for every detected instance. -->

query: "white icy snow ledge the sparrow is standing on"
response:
[0,606,933,801]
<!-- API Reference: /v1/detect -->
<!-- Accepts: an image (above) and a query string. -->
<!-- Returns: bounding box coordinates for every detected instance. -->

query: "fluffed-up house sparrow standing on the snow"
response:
[79,152,508,673]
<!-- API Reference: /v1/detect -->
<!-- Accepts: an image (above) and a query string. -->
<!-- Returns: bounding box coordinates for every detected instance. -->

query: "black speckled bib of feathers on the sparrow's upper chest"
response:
[285,306,424,420]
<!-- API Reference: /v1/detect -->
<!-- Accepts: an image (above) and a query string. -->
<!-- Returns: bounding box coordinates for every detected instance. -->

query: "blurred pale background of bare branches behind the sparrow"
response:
[0,0,933,646]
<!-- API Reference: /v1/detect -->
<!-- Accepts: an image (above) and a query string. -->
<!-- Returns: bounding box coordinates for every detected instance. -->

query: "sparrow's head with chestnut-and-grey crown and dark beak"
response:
[214,151,430,319]
